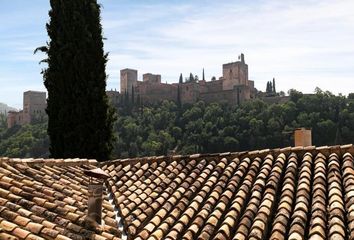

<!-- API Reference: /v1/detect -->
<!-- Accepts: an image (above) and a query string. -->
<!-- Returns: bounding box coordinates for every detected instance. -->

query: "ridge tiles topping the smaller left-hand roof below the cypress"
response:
[0,157,98,166]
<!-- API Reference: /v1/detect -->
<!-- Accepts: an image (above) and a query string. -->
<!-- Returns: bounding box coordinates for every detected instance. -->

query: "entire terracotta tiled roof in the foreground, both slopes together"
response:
[0,145,354,240]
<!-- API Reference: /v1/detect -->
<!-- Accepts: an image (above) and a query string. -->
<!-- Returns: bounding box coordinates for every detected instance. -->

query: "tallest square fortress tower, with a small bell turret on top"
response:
[222,53,249,90]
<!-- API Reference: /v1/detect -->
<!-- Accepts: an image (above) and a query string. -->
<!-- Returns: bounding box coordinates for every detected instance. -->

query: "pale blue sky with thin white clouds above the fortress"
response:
[0,0,354,108]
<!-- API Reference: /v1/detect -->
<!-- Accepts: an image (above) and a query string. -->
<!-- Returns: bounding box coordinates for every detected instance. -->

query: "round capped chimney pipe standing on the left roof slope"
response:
[84,168,110,224]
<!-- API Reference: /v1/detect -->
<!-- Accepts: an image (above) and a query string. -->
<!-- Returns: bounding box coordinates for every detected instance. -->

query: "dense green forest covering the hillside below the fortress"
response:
[0,89,354,158]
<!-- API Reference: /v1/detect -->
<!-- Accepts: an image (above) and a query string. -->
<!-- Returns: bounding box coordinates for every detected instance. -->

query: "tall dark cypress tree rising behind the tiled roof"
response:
[39,0,115,160]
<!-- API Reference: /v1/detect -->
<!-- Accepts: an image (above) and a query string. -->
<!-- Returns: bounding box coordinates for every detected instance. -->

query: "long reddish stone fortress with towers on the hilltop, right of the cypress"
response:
[116,54,257,104]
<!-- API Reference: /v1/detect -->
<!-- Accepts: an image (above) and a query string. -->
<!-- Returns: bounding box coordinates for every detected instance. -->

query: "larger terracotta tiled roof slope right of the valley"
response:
[102,145,354,240]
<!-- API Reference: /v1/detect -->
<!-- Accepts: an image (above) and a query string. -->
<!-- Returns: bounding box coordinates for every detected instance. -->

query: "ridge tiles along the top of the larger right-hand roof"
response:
[100,144,354,166]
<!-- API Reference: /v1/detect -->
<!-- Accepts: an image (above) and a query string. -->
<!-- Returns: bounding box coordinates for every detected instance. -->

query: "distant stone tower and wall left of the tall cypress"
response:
[7,91,47,128]
